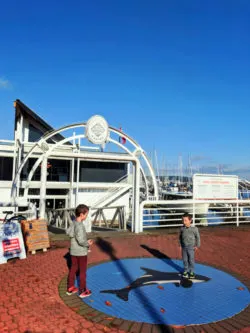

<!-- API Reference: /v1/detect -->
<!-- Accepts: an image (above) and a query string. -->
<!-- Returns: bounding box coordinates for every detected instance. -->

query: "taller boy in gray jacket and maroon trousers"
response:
[66,205,93,298]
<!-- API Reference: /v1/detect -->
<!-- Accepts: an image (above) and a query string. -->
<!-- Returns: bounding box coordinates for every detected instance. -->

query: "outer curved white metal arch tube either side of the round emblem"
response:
[11,122,158,198]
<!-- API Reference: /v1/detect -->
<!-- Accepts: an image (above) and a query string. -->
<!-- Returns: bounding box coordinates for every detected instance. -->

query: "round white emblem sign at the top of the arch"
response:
[85,116,109,145]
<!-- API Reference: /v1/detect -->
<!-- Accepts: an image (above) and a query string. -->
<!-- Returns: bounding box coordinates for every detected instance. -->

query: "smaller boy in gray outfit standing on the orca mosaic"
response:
[179,213,200,279]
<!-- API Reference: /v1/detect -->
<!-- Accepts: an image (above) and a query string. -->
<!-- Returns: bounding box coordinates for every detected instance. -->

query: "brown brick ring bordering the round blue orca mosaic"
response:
[58,256,250,333]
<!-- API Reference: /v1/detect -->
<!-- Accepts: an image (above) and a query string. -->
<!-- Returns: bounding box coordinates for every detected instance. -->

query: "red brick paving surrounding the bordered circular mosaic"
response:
[0,228,250,333]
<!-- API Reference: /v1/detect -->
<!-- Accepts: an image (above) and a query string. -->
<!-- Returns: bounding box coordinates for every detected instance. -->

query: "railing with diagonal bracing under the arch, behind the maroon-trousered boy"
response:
[46,206,127,232]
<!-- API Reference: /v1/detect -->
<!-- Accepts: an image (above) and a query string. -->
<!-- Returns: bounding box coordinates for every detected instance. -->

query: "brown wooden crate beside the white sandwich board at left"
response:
[21,220,50,254]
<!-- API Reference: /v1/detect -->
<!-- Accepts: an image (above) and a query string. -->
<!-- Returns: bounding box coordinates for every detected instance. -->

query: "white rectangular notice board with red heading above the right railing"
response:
[193,174,238,200]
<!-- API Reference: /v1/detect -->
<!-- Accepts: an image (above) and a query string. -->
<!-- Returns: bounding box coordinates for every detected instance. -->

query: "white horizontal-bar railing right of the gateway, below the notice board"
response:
[140,199,250,231]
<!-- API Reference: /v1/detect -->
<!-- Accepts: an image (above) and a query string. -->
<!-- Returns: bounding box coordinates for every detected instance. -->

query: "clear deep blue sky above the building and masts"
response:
[0,0,250,175]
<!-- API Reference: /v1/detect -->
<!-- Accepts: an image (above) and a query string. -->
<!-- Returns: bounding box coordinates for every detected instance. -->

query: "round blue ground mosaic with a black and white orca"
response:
[80,258,250,325]
